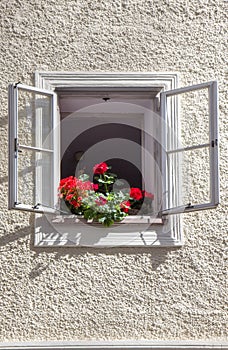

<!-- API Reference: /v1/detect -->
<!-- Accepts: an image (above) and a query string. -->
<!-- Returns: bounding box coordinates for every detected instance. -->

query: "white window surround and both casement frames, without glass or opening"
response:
[9,72,219,247]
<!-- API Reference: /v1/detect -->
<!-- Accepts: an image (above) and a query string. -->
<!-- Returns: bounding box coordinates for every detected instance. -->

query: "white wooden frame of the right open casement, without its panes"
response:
[161,81,219,215]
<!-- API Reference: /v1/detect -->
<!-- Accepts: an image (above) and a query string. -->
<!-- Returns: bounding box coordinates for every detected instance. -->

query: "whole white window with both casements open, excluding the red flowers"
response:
[9,72,219,246]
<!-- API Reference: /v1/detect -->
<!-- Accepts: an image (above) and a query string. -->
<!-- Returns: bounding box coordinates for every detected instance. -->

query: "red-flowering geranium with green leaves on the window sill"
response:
[58,162,153,227]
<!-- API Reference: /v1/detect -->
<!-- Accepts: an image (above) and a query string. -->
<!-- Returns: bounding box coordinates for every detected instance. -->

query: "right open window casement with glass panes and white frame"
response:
[161,81,219,214]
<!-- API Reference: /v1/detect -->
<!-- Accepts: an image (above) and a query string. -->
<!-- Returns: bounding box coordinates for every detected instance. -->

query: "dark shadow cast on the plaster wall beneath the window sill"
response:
[0,215,178,279]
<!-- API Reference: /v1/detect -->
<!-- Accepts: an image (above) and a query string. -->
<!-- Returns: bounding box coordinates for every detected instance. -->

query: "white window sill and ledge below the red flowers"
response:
[34,214,182,248]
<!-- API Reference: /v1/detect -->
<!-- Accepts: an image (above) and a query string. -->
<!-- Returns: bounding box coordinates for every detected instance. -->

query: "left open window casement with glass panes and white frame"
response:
[8,83,59,213]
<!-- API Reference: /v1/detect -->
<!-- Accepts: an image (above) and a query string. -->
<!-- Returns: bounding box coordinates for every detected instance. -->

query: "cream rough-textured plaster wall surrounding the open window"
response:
[0,0,227,341]
